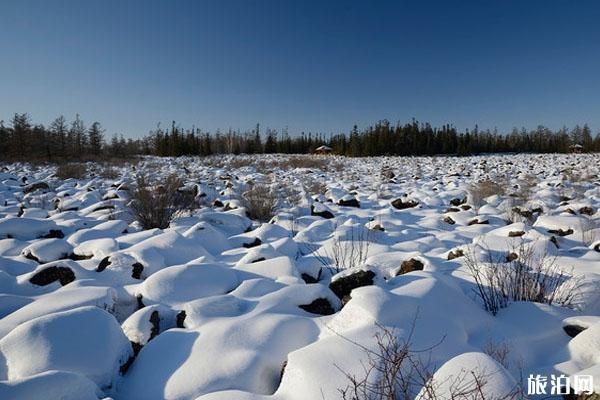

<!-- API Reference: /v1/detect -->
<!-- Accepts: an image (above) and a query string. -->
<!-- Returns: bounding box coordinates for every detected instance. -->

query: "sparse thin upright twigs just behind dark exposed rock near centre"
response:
[313,227,371,273]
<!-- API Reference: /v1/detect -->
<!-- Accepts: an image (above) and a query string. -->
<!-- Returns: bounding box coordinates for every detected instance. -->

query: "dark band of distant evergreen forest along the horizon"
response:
[0,114,600,161]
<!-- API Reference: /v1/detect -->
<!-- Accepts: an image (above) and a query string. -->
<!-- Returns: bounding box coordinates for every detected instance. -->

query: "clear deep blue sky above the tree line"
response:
[0,0,600,137]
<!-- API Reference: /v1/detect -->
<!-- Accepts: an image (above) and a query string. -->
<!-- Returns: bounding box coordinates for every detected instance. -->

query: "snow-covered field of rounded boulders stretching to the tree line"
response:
[0,155,600,400]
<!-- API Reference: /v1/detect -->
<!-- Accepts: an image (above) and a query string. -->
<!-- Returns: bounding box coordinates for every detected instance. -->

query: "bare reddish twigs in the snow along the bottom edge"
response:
[336,322,524,400]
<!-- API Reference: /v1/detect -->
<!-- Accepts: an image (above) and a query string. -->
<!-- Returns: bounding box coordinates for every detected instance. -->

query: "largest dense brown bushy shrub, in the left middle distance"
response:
[129,175,195,229]
